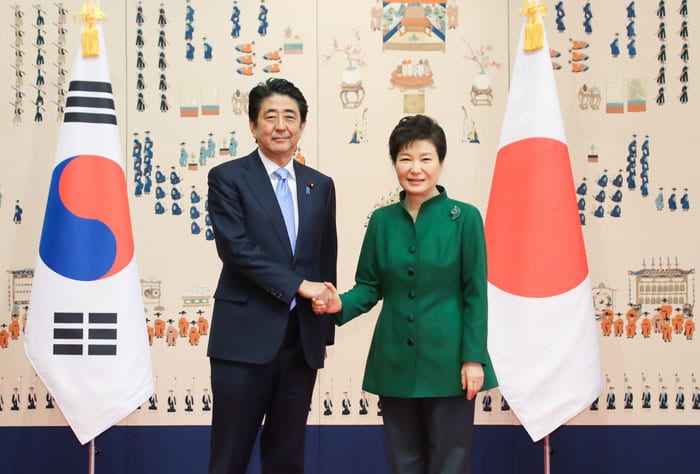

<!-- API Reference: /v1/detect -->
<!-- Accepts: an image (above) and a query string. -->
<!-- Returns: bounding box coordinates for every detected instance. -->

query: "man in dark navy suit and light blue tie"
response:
[207,79,337,474]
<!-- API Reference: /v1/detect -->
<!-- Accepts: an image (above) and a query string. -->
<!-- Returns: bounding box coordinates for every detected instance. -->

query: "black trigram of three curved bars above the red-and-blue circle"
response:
[63,81,117,125]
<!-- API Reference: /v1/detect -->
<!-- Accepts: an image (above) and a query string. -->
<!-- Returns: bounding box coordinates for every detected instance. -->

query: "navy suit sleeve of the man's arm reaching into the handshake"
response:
[208,168,303,304]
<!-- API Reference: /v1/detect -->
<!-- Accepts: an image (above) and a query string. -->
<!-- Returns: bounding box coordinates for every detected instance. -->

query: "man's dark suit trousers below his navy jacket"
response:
[209,310,316,474]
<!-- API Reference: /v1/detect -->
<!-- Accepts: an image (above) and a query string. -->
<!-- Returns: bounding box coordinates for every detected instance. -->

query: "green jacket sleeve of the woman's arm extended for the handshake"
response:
[333,214,382,326]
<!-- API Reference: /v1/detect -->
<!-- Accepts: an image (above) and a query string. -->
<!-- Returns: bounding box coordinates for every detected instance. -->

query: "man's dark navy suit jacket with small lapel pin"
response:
[207,150,338,368]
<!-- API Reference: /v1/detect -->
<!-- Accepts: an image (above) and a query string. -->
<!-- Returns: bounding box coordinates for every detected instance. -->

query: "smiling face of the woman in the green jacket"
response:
[396,140,442,199]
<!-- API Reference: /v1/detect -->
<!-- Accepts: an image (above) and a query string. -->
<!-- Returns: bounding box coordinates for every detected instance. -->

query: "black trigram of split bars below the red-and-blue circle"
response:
[53,313,117,356]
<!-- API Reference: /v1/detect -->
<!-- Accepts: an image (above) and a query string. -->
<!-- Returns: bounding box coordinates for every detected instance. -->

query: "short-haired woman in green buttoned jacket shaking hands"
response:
[314,115,496,474]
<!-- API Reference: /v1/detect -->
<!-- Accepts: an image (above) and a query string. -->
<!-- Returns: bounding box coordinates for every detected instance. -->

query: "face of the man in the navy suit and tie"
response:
[250,94,306,166]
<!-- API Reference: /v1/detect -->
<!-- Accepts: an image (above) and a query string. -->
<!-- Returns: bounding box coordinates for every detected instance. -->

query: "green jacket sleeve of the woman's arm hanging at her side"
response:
[461,206,490,364]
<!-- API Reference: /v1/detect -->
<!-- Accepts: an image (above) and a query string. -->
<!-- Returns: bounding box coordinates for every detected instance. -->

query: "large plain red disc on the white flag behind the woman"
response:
[485,138,588,298]
